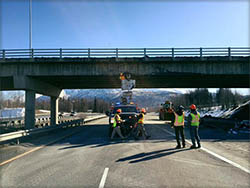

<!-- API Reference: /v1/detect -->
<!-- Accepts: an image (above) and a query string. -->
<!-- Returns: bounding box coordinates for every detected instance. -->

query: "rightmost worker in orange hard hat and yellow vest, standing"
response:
[188,104,201,149]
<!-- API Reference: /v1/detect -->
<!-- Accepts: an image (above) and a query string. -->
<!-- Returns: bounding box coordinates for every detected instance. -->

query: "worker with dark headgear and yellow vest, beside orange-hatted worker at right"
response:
[172,106,186,149]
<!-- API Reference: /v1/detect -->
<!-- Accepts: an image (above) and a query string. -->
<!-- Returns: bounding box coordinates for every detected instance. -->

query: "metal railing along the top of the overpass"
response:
[0,47,250,59]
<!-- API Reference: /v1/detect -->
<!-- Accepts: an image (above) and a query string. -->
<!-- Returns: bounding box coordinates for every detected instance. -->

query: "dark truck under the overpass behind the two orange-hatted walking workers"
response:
[109,104,139,136]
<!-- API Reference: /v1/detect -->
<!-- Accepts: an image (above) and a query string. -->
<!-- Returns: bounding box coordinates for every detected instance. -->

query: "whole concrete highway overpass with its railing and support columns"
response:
[0,48,250,128]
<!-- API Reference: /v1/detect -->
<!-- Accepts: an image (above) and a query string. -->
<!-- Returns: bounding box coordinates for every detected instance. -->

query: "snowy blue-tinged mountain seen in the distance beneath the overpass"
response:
[0,89,185,107]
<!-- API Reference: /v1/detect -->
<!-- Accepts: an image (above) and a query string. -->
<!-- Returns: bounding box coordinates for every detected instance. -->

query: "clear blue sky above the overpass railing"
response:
[0,0,250,49]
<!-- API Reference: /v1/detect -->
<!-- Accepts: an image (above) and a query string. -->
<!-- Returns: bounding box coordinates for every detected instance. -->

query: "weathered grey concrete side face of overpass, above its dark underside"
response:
[0,57,249,76]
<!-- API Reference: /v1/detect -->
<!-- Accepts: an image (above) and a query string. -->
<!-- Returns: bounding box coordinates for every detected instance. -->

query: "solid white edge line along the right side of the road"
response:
[158,127,250,174]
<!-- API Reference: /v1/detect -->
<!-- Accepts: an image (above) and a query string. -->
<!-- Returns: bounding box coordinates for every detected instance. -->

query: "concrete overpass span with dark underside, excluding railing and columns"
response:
[0,57,250,90]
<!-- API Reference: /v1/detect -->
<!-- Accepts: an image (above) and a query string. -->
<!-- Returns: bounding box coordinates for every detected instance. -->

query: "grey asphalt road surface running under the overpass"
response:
[0,115,250,188]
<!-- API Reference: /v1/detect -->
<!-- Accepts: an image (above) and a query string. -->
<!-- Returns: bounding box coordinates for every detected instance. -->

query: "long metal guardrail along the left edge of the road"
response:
[0,115,106,143]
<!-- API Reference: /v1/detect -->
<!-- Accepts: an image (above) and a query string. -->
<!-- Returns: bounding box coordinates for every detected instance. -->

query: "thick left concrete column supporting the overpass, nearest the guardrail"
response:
[25,90,36,129]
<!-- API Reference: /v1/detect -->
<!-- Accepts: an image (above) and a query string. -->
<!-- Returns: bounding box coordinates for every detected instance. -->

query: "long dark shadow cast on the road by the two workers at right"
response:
[116,148,190,163]
